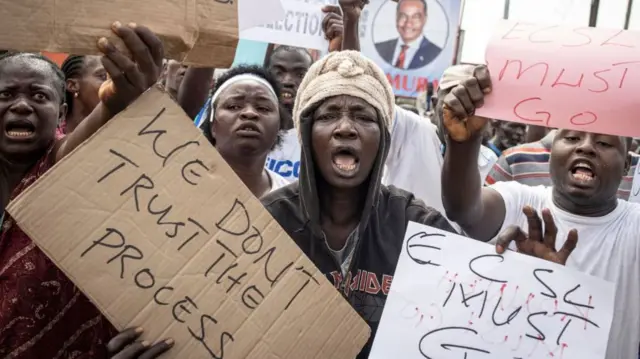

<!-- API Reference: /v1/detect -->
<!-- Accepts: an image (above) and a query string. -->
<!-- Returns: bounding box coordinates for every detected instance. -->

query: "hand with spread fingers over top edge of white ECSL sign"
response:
[496,206,578,265]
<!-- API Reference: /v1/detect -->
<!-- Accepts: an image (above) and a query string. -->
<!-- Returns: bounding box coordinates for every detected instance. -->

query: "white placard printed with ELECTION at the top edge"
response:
[240,0,329,50]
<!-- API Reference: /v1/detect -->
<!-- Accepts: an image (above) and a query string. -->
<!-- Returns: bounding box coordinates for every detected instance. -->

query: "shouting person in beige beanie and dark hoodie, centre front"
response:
[263,51,453,358]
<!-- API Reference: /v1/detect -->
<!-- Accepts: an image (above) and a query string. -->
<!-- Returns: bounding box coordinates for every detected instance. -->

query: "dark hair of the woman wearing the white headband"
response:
[201,65,290,148]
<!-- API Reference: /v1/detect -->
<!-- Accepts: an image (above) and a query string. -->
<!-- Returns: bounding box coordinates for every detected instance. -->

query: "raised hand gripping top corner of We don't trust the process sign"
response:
[98,22,164,114]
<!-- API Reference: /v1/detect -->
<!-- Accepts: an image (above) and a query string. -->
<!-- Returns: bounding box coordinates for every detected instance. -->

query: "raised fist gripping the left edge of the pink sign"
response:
[441,65,491,142]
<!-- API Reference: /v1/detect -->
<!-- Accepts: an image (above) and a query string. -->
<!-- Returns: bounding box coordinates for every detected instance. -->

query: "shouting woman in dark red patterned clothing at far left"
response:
[0,23,171,359]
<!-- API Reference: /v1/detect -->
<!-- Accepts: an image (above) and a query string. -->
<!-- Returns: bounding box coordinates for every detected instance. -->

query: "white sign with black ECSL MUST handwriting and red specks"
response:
[369,222,614,359]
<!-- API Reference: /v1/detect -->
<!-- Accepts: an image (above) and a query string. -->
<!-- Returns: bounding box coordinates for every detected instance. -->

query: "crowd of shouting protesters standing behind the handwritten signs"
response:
[0,0,640,359]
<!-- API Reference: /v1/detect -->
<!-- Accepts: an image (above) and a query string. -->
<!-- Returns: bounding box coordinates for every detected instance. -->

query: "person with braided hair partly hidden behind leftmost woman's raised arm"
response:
[60,55,107,134]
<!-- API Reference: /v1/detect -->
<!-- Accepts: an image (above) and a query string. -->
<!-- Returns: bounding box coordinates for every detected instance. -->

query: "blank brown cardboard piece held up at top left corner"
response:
[0,0,238,67]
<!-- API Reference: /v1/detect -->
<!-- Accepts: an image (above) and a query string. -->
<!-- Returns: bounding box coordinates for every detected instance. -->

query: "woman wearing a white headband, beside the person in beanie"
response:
[202,66,288,198]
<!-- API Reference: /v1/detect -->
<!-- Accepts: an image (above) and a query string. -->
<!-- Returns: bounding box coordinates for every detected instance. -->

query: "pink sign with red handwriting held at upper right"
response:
[477,21,640,137]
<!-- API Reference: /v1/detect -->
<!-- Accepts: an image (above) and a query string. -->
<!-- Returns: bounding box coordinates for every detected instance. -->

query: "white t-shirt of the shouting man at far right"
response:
[490,181,640,359]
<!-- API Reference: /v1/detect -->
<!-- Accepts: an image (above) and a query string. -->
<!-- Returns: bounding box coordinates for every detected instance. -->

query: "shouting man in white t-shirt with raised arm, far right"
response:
[438,66,640,359]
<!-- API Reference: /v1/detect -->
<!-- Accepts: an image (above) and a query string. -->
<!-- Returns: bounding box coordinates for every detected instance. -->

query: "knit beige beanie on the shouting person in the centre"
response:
[293,51,395,137]
